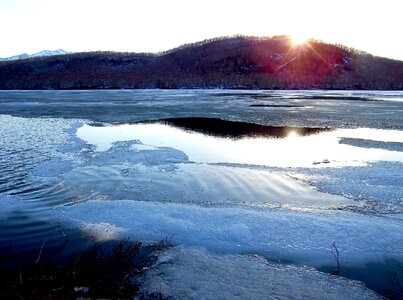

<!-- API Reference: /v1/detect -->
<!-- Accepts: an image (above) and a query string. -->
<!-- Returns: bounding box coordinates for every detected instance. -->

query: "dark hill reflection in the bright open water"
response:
[152,118,332,139]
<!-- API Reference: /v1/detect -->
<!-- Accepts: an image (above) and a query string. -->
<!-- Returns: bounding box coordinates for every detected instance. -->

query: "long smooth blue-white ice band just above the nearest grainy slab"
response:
[54,200,403,267]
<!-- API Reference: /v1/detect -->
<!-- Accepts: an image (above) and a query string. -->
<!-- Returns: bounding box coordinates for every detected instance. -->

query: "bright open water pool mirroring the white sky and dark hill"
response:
[77,118,403,167]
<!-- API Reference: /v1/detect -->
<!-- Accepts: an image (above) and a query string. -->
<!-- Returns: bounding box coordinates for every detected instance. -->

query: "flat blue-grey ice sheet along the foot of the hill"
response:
[0,90,403,129]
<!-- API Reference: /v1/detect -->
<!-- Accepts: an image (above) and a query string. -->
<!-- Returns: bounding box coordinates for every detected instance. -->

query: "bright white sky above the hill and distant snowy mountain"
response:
[0,0,403,60]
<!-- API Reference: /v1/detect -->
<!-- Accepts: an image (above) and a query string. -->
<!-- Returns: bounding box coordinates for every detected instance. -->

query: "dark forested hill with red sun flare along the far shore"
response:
[0,36,403,90]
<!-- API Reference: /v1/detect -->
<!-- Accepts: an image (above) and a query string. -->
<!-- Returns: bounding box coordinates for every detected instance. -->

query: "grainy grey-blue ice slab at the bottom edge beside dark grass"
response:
[140,247,380,299]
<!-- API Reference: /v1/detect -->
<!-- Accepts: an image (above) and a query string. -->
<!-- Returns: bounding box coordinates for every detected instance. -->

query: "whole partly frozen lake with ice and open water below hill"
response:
[0,90,403,299]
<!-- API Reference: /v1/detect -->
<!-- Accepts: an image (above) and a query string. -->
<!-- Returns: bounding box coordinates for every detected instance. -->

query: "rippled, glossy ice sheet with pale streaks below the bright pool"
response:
[56,161,361,210]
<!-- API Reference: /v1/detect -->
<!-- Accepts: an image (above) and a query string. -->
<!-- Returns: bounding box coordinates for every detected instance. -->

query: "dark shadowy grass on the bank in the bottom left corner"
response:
[0,239,168,299]
